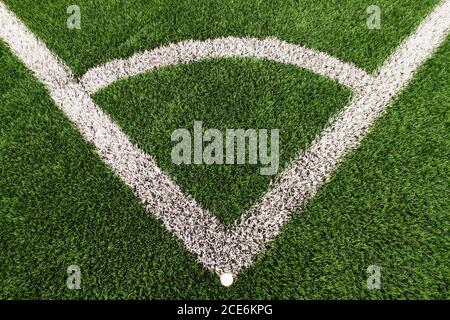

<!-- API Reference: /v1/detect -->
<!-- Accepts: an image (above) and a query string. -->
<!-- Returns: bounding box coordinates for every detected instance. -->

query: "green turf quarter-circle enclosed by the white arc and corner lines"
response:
[94,59,351,224]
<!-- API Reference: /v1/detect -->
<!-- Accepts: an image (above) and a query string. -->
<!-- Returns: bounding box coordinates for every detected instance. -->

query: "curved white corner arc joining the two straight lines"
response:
[81,37,371,93]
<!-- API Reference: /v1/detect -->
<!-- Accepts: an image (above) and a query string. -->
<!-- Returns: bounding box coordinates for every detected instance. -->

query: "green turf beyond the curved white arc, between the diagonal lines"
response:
[4,0,439,75]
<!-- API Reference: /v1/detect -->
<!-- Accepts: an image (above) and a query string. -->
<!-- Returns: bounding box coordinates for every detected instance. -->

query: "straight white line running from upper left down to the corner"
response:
[0,2,225,269]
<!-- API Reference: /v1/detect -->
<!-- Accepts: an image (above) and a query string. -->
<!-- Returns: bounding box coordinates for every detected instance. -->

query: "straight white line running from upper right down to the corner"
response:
[230,0,450,272]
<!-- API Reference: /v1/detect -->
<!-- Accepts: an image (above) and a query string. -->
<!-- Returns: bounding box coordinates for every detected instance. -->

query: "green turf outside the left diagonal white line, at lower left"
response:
[0,43,214,299]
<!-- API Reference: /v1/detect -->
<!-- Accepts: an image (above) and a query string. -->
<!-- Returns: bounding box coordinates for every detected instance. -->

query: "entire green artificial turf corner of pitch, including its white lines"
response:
[0,0,450,299]
